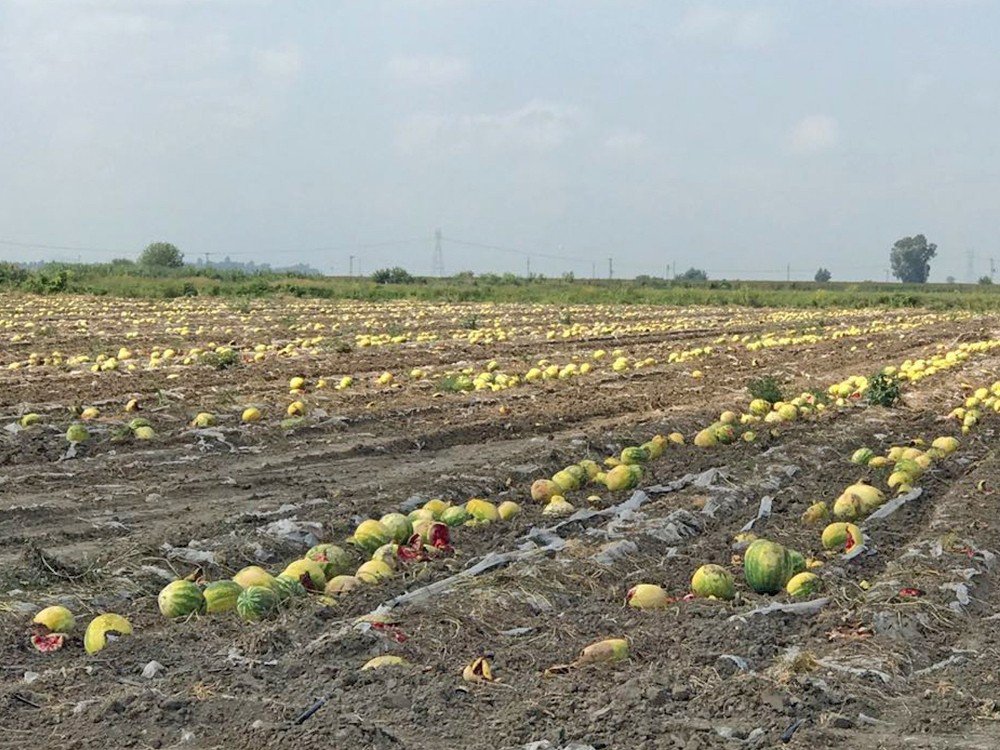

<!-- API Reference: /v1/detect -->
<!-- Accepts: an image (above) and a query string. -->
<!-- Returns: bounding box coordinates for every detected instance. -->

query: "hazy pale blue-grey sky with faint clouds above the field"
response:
[0,0,1000,280]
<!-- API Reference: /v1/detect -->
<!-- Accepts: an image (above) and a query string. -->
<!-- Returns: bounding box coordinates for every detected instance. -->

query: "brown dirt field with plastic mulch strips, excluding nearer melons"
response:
[0,297,1000,749]
